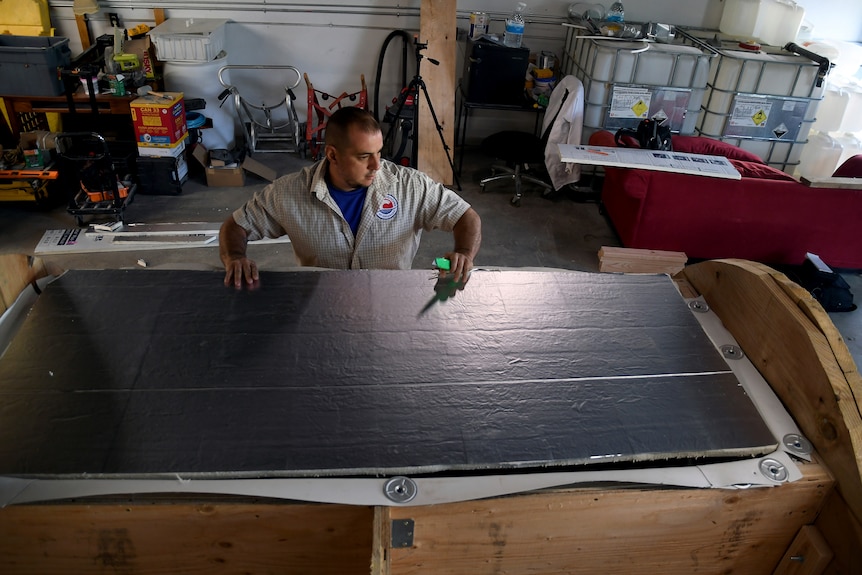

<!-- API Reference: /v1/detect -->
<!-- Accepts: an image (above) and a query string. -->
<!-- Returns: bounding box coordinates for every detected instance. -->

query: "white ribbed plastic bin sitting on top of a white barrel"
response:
[150,18,228,62]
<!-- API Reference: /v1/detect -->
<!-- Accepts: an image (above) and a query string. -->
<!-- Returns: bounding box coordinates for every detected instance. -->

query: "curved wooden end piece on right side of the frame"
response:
[685,260,862,532]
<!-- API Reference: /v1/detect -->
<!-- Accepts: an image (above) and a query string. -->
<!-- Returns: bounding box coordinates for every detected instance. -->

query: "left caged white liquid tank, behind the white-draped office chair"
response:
[563,27,713,143]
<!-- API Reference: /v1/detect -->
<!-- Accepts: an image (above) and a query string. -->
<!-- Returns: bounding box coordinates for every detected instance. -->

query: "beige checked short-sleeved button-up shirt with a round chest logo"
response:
[233,159,470,269]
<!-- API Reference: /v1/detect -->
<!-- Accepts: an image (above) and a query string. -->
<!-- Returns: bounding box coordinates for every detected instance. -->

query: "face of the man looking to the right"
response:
[326,127,383,191]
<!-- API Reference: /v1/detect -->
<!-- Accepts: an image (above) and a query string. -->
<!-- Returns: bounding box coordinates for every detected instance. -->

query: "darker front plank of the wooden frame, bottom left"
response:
[0,499,373,575]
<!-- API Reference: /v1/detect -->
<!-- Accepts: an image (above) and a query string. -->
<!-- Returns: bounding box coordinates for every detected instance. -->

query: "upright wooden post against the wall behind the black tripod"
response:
[416,0,457,185]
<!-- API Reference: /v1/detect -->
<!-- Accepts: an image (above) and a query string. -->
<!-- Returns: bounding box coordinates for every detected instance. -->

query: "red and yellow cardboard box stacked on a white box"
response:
[130,92,188,148]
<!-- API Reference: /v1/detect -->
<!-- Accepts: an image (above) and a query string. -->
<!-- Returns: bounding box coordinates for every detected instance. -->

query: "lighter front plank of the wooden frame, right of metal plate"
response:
[389,464,832,575]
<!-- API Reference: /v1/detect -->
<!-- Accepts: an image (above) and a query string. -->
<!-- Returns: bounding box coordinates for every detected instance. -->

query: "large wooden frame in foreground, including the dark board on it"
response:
[0,262,862,574]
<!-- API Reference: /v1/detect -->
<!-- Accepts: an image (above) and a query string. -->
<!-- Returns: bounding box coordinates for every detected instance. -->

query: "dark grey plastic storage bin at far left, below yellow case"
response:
[0,34,72,96]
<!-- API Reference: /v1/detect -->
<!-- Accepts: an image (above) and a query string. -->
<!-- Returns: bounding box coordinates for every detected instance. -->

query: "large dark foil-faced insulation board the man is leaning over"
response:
[0,270,777,478]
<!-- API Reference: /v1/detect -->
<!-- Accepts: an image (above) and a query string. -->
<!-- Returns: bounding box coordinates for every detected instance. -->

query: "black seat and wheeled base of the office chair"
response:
[479,130,554,207]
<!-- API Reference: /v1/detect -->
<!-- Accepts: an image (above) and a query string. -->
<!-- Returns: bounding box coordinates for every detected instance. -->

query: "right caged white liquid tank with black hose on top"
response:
[677,29,829,174]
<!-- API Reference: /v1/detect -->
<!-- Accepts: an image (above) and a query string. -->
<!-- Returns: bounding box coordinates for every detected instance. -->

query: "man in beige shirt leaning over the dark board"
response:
[219,106,482,288]
